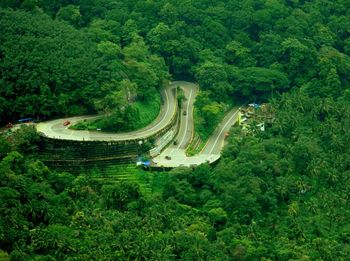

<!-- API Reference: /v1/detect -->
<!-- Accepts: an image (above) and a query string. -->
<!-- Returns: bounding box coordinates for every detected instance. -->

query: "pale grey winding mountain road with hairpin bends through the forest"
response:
[36,81,239,168]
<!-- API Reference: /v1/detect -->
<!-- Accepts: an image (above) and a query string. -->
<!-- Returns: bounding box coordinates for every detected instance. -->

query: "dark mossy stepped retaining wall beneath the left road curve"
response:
[40,88,178,168]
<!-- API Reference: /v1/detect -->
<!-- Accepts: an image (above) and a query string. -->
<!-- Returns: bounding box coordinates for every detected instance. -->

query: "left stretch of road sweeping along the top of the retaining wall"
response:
[36,82,179,141]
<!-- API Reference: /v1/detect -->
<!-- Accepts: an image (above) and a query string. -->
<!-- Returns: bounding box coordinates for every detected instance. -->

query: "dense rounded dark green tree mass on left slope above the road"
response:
[0,7,168,123]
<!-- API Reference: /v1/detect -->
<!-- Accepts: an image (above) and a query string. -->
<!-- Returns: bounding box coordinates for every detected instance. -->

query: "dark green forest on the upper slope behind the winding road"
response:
[0,0,350,123]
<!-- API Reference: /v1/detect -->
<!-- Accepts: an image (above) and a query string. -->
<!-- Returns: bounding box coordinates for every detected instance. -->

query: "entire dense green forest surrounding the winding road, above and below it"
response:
[0,0,350,260]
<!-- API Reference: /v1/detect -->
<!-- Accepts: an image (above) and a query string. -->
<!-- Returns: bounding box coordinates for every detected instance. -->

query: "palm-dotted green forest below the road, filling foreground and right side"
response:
[0,92,350,260]
